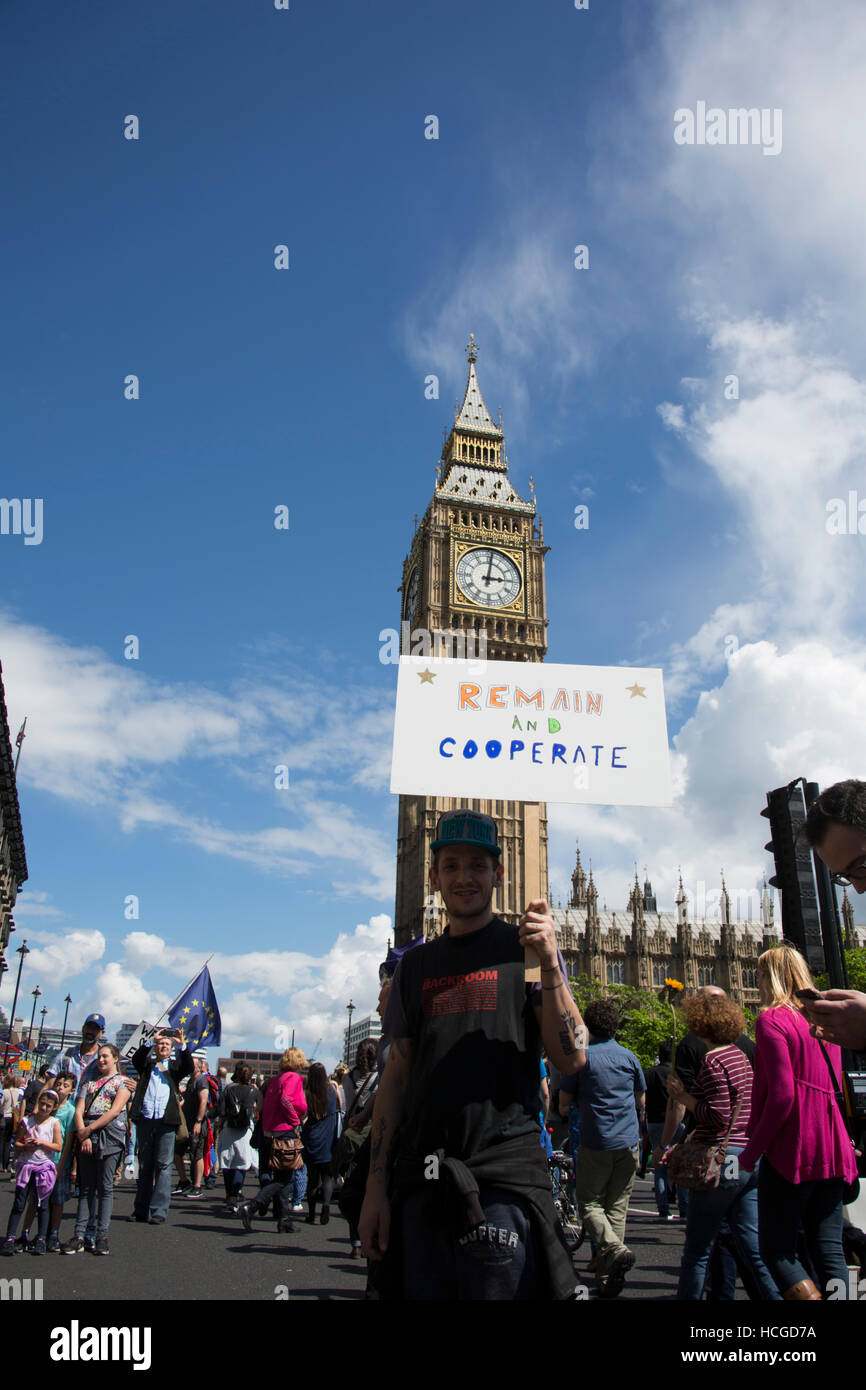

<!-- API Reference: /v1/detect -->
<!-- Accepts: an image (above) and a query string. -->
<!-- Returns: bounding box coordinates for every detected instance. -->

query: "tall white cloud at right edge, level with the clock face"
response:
[659,318,866,632]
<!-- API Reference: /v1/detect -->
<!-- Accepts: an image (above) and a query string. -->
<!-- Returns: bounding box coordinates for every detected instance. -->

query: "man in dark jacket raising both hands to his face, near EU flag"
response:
[129,1029,195,1226]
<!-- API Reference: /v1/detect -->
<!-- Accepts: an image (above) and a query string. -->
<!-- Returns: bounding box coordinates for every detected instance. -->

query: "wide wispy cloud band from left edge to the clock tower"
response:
[0,616,393,915]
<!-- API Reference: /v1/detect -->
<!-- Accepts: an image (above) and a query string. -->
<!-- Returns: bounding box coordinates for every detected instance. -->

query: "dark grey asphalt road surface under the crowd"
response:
[0,1179,745,1302]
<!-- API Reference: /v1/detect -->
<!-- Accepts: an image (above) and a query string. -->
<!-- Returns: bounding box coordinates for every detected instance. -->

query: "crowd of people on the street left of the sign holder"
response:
[0,1015,378,1258]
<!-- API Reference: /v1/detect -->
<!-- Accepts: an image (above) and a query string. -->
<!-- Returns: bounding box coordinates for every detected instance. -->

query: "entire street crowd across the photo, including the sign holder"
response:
[0,783,866,1302]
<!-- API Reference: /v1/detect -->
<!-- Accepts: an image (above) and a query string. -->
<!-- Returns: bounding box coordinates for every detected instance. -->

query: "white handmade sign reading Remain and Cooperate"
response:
[391,656,671,806]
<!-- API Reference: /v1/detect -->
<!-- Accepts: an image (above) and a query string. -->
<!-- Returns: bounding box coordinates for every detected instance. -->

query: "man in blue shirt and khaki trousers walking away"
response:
[560,999,646,1298]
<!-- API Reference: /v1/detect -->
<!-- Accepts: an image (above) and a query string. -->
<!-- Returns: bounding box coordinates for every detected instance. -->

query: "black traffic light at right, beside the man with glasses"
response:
[760,778,824,974]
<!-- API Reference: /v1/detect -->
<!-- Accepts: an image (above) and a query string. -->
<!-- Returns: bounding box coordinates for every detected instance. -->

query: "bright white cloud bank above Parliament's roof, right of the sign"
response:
[552,641,866,910]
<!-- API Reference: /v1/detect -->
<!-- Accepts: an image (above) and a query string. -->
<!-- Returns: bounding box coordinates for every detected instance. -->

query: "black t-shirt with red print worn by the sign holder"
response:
[384,917,541,1158]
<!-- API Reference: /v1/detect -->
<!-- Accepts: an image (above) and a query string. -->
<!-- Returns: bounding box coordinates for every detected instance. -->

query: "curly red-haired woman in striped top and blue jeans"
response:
[667,994,781,1302]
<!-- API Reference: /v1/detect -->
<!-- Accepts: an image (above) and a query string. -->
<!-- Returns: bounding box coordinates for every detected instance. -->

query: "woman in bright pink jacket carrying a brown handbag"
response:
[238,1047,307,1233]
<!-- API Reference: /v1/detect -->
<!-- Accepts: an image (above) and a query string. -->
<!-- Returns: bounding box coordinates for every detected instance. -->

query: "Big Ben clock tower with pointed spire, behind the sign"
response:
[395,335,548,945]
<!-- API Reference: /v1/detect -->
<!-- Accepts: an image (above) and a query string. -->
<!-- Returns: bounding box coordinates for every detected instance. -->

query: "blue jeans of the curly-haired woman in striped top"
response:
[677,1145,781,1302]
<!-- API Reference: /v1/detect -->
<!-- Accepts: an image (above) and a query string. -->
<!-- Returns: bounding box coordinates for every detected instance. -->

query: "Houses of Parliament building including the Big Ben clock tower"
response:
[395,336,862,1005]
